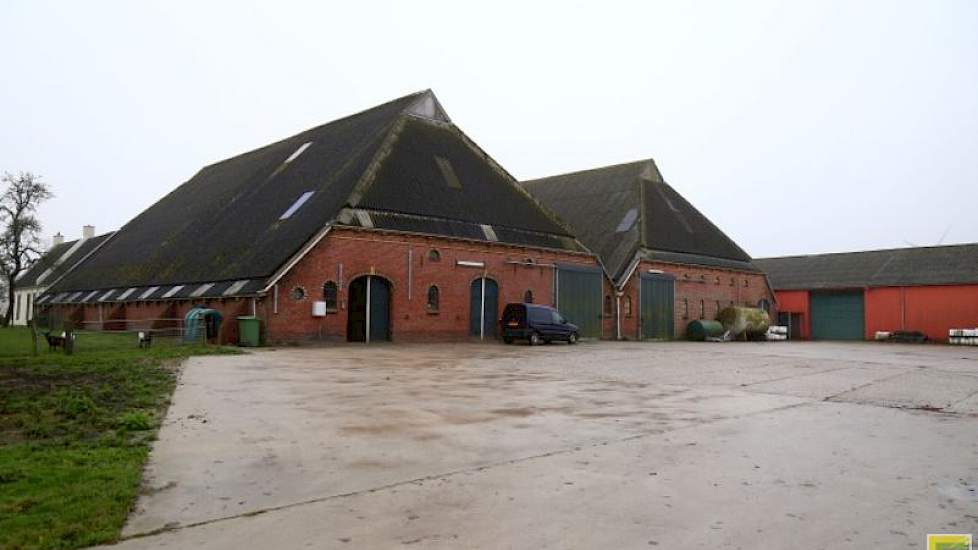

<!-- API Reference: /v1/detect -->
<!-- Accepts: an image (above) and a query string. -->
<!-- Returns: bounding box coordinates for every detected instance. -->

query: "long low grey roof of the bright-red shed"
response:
[754,243,978,290]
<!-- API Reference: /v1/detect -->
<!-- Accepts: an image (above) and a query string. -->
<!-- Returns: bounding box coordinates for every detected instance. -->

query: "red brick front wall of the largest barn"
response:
[260,229,596,342]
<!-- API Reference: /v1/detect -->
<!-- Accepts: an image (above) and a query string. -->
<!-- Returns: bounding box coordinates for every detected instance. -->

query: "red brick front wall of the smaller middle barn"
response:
[605,261,774,340]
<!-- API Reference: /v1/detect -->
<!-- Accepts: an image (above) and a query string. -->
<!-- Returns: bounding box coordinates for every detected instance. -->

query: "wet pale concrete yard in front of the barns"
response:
[103,342,978,550]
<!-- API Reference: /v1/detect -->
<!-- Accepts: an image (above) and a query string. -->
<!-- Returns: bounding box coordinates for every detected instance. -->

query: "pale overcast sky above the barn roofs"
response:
[0,0,978,257]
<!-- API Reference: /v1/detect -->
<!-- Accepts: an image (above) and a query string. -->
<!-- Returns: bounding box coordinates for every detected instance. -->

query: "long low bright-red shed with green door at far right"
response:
[756,244,978,341]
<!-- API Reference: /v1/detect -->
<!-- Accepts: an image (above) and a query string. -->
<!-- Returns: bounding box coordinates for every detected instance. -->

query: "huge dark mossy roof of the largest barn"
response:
[51,91,581,297]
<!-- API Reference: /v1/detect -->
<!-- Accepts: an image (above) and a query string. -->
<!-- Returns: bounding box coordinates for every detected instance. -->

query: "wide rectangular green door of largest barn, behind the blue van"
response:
[556,265,604,338]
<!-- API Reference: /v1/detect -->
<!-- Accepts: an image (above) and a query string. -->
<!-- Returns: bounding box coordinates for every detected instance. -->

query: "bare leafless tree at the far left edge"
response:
[0,172,54,326]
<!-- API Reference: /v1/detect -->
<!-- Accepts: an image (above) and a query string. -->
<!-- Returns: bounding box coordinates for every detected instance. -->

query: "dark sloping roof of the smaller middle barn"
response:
[523,159,755,282]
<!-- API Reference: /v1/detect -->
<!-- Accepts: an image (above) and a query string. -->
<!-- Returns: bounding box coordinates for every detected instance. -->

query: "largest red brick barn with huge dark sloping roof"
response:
[37,91,602,348]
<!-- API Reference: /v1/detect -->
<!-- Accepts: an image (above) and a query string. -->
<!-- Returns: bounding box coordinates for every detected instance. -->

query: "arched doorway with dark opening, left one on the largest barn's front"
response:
[346,275,391,342]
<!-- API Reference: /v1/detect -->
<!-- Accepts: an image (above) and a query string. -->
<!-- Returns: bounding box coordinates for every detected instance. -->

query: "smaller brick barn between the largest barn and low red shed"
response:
[523,159,773,339]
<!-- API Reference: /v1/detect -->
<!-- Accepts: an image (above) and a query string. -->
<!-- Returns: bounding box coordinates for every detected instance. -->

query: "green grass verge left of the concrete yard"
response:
[0,328,236,550]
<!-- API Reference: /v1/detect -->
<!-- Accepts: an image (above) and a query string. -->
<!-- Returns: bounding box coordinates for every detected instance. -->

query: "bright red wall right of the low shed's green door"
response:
[864,285,978,341]
